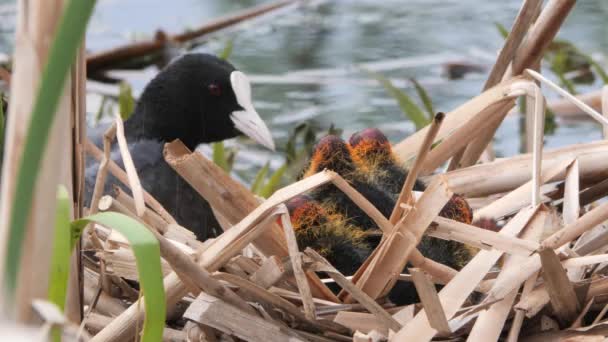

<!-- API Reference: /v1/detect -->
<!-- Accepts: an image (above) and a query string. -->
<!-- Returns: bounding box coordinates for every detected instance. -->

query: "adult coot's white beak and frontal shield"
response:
[230,71,274,151]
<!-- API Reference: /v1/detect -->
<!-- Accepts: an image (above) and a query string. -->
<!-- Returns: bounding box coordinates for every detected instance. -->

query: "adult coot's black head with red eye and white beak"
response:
[126,53,274,149]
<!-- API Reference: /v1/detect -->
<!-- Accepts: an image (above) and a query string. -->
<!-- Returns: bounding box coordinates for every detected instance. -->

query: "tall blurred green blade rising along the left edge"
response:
[4,0,95,305]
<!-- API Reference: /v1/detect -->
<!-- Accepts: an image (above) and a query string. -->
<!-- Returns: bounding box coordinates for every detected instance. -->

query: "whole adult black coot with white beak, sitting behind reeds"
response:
[85,53,274,240]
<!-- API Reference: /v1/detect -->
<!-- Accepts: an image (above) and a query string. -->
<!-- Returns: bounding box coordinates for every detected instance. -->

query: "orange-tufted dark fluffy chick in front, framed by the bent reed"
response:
[285,195,371,275]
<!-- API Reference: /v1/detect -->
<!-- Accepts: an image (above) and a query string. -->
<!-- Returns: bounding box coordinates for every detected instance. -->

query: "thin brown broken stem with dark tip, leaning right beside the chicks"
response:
[389,112,445,225]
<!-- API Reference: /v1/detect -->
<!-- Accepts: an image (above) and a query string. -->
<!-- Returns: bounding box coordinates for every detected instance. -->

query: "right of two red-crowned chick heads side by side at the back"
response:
[349,128,394,165]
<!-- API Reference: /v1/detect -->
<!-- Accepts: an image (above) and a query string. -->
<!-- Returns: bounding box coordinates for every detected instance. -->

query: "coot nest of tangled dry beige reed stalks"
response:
[73,1,608,341]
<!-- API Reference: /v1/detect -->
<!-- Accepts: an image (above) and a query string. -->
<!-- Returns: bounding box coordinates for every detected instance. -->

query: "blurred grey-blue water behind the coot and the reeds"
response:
[0,0,608,174]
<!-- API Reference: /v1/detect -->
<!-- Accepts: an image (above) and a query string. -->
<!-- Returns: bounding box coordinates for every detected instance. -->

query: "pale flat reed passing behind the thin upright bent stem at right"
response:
[474,159,574,220]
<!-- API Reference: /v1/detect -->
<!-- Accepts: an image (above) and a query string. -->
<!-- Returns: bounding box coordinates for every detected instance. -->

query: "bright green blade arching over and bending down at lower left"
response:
[71,212,166,342]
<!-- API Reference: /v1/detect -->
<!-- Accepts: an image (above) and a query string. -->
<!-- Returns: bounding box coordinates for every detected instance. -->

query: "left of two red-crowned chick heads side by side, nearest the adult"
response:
[304,135,355,177]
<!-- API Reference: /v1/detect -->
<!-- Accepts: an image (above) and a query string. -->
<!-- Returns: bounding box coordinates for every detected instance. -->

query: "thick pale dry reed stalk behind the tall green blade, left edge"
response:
[0,0,77,323]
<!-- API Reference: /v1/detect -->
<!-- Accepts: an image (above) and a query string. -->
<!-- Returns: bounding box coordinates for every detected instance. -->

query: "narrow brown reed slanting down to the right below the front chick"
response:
[306,248,401,331]
